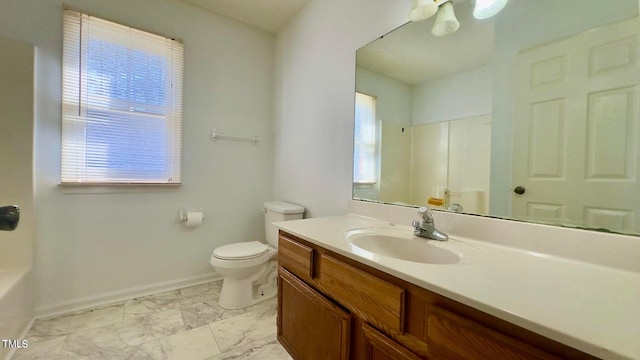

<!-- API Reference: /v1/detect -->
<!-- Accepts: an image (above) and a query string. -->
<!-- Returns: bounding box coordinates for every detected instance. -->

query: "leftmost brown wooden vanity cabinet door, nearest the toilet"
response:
[278,267,351,360]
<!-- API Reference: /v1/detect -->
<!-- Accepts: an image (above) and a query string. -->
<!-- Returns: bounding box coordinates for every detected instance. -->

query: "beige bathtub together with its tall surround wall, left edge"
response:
[0,37,35,358]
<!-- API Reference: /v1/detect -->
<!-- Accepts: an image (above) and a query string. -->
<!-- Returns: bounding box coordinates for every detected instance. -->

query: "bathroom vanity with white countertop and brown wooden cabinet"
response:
[277,207,640,360]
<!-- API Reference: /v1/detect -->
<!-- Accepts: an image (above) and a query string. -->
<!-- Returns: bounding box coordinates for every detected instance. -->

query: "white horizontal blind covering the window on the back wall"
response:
[61,10,183,184]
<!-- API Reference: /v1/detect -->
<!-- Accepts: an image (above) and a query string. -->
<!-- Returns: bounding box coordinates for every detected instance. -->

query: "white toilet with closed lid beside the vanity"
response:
[211,201,304,309]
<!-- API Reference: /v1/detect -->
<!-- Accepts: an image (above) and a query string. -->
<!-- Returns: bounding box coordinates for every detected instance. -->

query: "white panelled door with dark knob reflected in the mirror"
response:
[511,18,640,232]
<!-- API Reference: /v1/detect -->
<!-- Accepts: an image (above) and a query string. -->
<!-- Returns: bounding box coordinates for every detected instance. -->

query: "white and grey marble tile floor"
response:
[12,281,289,360]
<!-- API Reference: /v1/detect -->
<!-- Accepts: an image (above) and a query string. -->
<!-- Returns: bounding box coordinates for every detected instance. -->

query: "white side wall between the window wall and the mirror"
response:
[274,0,411,217]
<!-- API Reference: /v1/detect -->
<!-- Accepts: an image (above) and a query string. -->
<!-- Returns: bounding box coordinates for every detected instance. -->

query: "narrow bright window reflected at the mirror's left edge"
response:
[353,93,378,184]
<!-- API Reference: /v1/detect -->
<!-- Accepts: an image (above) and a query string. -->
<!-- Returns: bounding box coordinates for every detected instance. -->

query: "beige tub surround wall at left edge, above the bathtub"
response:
[0,38,35,269]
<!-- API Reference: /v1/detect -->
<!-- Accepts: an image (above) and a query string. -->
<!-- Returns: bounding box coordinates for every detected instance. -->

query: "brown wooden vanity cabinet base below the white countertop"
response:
[278,231,596,360]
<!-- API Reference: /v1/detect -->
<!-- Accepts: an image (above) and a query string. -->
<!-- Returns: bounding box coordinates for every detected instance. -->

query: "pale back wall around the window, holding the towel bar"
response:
[0,0,276,314]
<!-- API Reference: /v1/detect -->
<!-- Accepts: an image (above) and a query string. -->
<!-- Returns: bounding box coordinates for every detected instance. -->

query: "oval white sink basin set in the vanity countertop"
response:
[343,228,460,264]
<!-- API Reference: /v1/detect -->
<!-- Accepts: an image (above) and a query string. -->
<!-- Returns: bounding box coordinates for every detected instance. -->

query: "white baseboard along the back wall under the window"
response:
[34,272,222,319]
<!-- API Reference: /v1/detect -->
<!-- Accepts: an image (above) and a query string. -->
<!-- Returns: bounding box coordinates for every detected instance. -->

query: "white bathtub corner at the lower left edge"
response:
[0,268,33,359]
